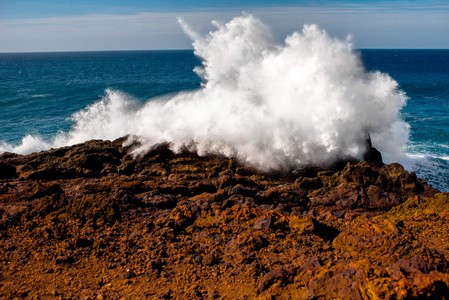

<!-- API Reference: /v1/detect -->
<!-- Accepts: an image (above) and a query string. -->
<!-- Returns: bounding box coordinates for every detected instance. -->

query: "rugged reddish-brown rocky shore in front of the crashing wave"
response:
[0,139,449,299]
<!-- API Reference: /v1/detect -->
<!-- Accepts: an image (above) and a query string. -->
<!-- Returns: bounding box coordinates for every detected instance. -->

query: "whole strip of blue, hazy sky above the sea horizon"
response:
[0,0,449,52]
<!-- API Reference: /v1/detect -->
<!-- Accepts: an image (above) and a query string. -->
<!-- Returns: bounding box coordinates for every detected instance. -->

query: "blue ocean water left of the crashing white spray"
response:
[0,50,201,144]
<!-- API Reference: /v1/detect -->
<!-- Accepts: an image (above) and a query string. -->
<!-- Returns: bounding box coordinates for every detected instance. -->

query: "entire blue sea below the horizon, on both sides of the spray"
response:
[0,49,449,191]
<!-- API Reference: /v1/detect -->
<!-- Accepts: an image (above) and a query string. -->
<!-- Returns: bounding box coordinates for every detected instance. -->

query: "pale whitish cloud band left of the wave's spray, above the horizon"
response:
[0,13,197,52]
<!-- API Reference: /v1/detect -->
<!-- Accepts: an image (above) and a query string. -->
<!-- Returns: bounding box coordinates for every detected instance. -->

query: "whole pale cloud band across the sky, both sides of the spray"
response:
[0,3,449,52]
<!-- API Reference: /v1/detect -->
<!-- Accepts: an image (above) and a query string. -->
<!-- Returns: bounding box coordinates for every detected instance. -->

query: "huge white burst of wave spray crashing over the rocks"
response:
[0,15,408,170]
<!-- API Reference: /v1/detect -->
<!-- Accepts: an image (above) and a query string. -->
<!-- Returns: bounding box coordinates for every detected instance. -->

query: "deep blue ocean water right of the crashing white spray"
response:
[361,50,449,191]
